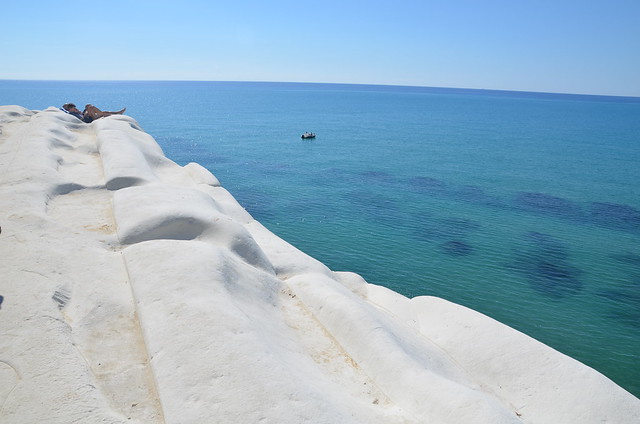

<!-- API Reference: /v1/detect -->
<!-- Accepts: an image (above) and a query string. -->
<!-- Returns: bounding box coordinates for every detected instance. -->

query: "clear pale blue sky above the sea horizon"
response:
[0,0,640,96]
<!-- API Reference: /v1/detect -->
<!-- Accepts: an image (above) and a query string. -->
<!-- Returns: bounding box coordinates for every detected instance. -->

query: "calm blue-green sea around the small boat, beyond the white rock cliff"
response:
[0,80,640,397]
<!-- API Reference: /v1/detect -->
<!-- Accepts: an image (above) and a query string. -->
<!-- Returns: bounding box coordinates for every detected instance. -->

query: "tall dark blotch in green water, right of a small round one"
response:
[512,232,582,299]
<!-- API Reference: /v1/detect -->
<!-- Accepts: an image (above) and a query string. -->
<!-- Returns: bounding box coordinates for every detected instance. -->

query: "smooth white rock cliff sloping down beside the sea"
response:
[0,106,640,423]
